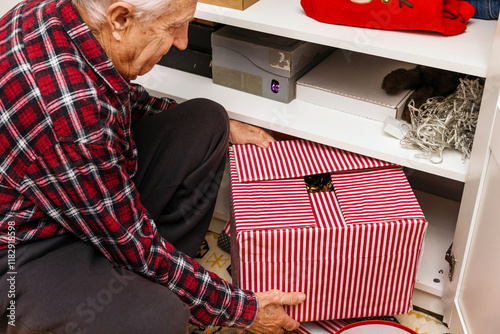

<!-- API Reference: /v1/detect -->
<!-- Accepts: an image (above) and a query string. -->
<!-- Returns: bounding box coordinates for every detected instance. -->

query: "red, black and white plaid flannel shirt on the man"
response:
[0,0,257,327]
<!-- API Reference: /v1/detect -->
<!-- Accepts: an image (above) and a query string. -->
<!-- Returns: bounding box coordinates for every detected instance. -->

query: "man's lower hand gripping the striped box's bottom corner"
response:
[247,290,306,334]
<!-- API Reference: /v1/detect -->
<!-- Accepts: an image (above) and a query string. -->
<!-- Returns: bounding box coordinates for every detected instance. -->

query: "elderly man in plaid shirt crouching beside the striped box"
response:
[0,0,305,334]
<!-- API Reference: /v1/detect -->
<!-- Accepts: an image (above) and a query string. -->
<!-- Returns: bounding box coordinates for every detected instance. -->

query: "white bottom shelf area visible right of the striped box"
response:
[414,190,460,297]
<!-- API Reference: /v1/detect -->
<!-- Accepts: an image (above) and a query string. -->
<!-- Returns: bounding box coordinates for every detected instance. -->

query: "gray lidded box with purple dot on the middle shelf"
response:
[212,26,332,103]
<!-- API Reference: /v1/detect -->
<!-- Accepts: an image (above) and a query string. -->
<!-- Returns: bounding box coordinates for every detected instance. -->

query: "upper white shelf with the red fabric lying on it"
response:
[195,0,497,77]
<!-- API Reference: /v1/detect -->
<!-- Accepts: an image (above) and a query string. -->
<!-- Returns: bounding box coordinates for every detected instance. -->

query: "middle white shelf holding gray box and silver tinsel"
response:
[136,65,468,182]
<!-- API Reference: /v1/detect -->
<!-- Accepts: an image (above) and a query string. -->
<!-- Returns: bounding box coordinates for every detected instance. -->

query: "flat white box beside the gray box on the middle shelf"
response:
[297,50,415,122]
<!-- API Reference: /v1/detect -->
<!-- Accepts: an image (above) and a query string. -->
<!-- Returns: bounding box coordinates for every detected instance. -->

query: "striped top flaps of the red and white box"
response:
[230,140,425,231]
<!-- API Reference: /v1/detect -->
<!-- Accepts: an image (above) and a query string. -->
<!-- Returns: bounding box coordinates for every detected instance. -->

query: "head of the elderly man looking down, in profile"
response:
[73,0,197,80]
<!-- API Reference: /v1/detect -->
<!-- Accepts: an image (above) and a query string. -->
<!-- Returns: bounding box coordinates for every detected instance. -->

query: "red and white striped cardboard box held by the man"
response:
[230,140,427,322]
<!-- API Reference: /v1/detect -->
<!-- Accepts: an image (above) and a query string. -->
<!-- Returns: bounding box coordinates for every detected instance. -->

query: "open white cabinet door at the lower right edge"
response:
[450,85,500,334]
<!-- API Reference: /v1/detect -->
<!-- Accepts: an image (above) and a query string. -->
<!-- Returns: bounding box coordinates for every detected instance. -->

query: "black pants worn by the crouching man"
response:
[0,99,228,334]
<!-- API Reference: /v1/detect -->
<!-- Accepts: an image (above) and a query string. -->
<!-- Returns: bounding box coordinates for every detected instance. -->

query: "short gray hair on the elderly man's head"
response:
[72,0,181,25]
